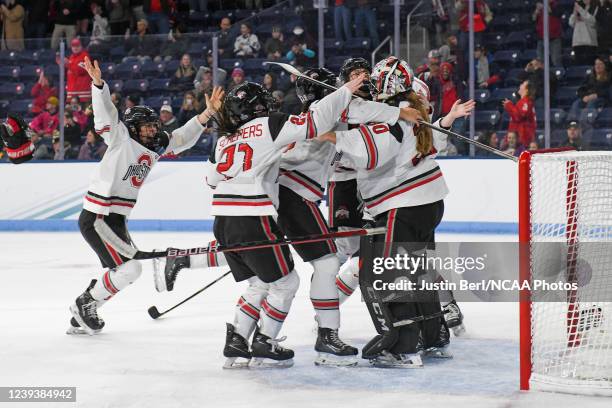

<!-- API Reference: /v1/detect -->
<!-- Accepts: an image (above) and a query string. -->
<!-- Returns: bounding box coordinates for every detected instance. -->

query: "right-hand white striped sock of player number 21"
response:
[260,271,300,339]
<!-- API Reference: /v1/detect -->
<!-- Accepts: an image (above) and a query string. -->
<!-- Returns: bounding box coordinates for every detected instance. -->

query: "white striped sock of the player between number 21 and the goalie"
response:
[310,254,340,329]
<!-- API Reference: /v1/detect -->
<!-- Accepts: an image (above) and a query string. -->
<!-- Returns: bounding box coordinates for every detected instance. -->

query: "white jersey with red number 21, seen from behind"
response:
[206,87,351,216]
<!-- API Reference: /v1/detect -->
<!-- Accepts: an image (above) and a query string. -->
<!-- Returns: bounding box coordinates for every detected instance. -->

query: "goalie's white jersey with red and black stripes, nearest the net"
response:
[336,107,448,216]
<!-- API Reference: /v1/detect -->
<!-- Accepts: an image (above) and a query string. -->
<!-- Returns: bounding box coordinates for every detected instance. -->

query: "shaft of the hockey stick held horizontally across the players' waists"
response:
[132,227,387,259]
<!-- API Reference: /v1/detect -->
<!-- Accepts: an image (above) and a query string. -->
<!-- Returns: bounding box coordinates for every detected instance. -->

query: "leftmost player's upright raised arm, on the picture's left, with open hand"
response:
[84,57,127,146]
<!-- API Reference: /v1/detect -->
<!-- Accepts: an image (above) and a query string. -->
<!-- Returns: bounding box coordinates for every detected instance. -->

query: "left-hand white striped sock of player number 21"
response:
[234,277,268,339]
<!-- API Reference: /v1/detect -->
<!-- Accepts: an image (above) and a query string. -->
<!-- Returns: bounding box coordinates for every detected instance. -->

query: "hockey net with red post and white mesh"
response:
[519,151,612,395]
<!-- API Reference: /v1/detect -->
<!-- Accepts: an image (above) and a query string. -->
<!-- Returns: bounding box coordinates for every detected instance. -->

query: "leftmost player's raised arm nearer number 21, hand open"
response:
[166,86,225,154]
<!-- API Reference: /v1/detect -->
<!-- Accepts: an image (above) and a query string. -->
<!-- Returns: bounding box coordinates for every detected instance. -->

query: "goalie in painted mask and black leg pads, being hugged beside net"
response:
[318,57,474,367]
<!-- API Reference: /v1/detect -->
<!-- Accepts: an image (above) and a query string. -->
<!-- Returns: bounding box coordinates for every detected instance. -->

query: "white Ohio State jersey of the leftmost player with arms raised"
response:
[83,83,204,216]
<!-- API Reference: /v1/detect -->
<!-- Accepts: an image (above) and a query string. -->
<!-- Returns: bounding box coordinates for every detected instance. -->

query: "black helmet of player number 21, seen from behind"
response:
[223,82,276,127]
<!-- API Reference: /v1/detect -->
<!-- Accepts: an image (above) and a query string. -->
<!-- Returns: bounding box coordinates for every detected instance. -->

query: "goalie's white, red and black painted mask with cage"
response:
[372,56,413,101]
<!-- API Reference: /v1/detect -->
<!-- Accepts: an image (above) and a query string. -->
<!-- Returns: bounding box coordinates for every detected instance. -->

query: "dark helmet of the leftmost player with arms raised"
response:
[123,105,170,154]
